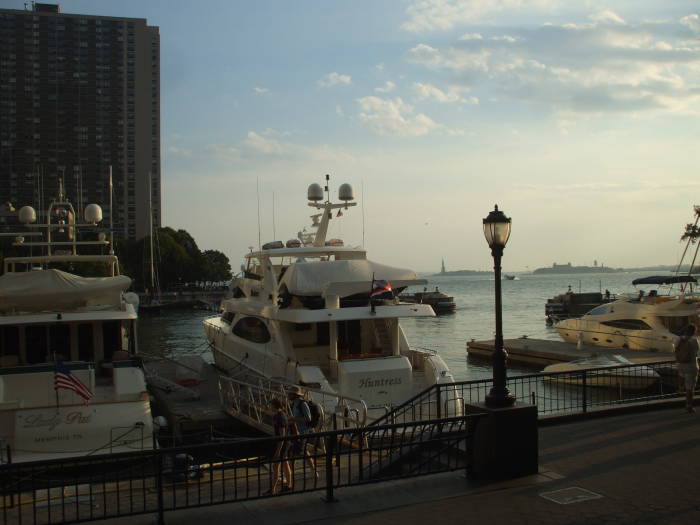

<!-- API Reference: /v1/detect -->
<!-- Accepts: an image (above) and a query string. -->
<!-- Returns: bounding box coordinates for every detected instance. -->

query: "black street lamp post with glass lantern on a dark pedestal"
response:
[484,206,515,408]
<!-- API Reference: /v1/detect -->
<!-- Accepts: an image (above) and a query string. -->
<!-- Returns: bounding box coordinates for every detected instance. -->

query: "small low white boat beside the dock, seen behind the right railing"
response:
[543,355,661,390]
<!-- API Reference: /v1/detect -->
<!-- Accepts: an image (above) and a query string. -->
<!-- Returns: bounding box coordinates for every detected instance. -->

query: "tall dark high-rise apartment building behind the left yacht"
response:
[0,3,161,239]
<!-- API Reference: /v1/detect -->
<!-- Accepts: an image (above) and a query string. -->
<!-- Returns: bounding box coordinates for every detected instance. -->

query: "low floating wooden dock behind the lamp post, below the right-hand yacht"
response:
[467,337,674,367]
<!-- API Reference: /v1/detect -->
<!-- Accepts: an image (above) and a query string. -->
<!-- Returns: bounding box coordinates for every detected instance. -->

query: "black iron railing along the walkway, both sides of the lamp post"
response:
[0,361,680,525]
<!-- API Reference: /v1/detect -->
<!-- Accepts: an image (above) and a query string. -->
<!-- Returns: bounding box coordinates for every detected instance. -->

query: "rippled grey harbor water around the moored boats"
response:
[139,272,650,381]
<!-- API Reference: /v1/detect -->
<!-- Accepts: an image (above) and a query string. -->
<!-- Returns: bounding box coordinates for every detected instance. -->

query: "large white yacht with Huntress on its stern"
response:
[204,178,463,421]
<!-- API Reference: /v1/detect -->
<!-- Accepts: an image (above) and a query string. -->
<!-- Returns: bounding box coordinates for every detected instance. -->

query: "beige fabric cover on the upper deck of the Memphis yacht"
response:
[0,269,131,313]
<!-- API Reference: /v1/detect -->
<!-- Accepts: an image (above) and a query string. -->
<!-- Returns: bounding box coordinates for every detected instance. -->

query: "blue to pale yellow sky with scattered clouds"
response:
[3,0,700,271]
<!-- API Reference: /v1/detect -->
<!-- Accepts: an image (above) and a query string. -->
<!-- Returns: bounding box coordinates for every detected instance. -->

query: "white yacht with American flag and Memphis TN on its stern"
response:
[0,180,153,463]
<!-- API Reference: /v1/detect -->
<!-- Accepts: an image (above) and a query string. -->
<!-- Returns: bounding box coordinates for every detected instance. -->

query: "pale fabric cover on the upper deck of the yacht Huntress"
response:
[280,259,426,297]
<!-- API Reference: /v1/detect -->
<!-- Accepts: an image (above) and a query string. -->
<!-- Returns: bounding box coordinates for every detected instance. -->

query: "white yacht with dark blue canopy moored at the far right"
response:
[555,276,700,353]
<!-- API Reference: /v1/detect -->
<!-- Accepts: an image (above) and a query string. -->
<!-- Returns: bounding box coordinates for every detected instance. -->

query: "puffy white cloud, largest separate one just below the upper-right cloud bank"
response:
[357,96,464,137]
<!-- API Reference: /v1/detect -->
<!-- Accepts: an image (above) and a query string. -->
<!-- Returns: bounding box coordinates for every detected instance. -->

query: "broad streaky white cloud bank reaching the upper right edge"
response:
[406,10,700,117]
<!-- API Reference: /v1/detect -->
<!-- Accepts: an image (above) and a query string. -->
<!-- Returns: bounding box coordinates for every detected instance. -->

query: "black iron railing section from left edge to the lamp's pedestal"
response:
[0,415,481,525]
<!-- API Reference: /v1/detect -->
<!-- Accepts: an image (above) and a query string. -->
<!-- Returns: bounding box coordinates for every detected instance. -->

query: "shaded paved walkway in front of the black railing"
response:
[110,408,700,525]
